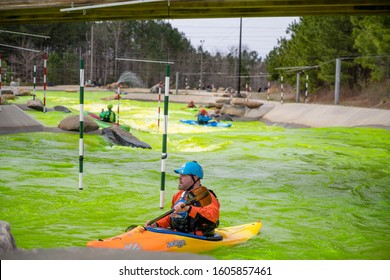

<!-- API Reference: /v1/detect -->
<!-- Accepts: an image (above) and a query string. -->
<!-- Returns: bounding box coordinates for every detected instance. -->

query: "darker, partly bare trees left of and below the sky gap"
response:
[0,20,265,91]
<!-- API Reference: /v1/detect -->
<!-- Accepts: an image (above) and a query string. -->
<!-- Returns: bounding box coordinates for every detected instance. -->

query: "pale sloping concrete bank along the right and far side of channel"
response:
[124,92,390,129]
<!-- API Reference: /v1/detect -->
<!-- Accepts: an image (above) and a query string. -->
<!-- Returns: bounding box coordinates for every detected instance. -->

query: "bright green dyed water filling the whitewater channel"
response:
[0,92,390,260]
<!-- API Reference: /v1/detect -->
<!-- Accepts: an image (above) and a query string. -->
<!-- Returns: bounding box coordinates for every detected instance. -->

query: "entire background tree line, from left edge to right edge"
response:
[0,16,390,96]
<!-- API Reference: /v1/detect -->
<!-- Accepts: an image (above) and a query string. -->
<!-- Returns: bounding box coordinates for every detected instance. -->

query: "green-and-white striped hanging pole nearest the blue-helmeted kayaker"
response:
[160,64,171,209]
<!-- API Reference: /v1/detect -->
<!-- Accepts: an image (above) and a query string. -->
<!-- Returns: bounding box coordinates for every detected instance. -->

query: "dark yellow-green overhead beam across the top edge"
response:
[0,0,390,24]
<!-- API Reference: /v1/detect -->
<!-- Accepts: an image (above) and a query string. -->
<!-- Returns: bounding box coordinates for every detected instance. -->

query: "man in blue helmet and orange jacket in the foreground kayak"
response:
[146,161,220,236]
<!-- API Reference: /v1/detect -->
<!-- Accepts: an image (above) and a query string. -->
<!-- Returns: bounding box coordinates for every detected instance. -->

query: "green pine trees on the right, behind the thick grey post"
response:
[266,16,390,94]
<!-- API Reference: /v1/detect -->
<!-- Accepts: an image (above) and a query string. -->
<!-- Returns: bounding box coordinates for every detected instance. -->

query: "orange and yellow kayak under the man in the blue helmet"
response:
[87,221,262,253]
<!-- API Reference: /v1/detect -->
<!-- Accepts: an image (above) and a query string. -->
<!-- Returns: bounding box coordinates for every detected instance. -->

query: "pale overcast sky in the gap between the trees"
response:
[169,17,299,58]
